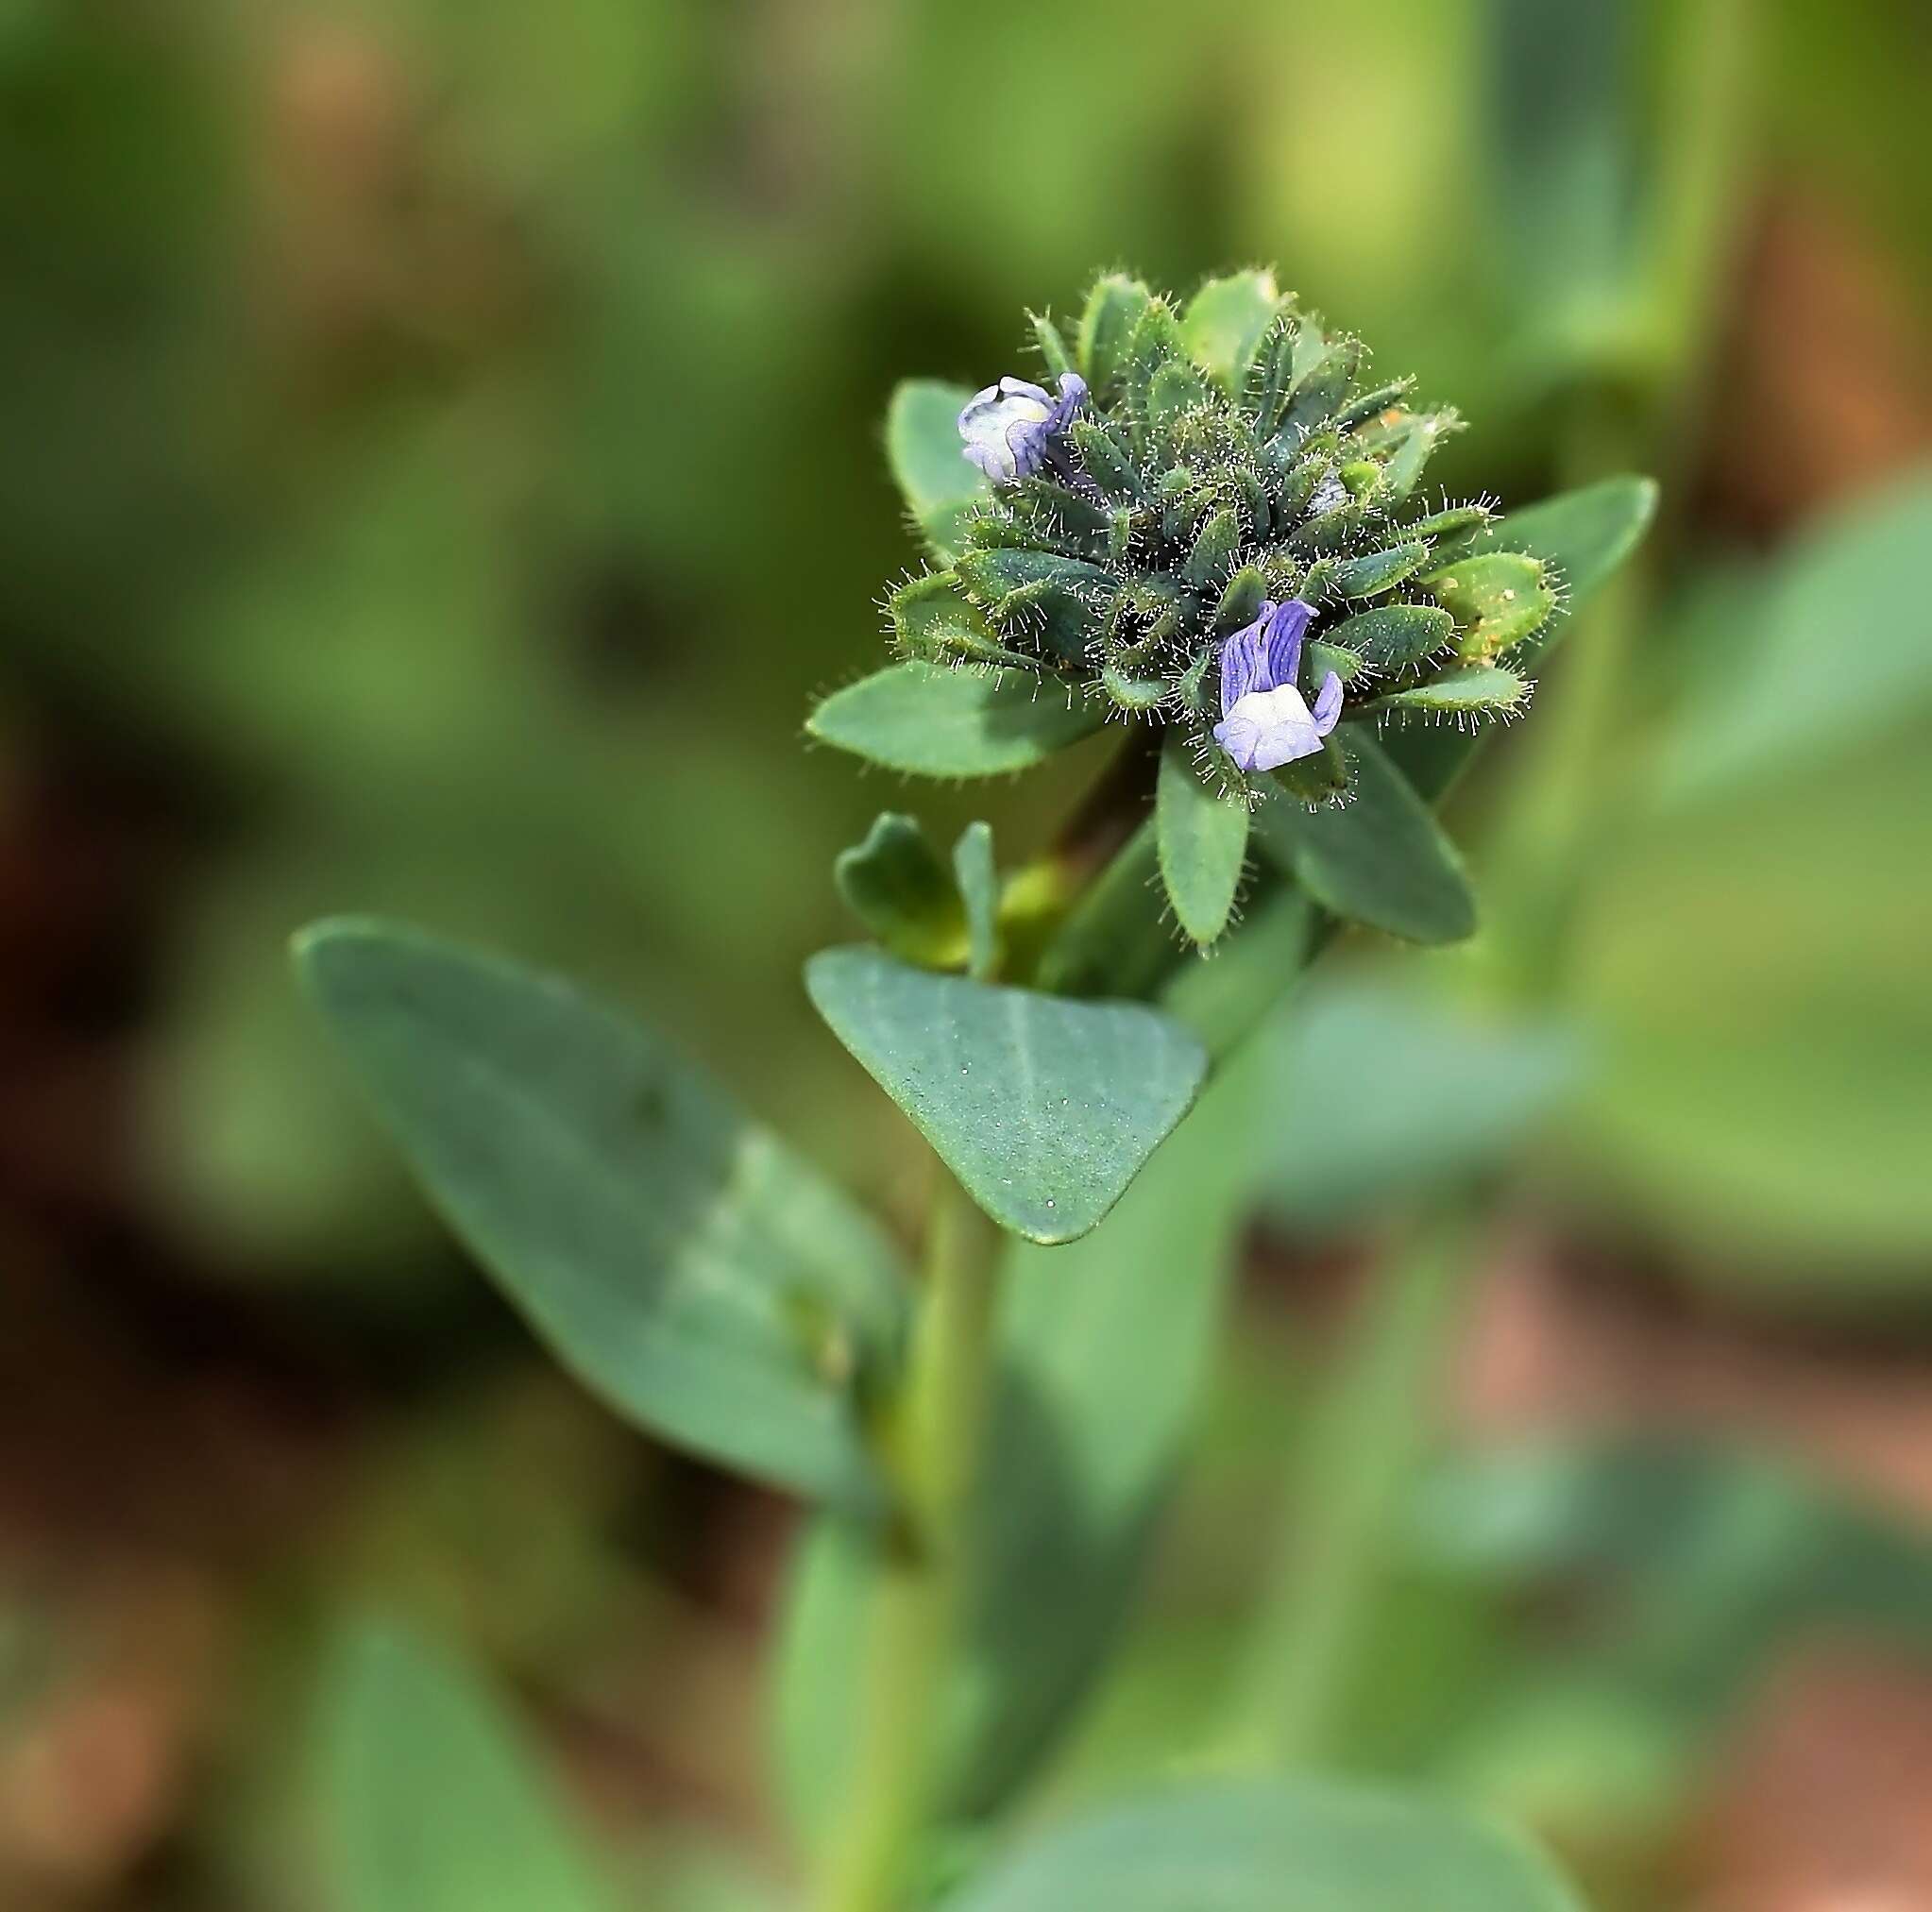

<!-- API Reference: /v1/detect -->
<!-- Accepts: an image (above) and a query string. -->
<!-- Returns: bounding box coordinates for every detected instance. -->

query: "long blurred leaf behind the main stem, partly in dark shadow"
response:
[776,1050,1293,1838]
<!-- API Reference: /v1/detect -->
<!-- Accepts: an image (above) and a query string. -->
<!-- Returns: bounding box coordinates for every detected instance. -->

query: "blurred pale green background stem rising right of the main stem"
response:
[1241,1213,1470,1766]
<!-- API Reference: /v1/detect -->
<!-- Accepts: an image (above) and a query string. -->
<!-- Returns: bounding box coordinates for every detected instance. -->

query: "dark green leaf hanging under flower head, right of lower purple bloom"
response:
[1256,734,1476,942]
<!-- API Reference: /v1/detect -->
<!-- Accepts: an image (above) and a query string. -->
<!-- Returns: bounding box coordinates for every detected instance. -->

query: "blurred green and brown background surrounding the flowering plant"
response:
[0,0,1932,1912]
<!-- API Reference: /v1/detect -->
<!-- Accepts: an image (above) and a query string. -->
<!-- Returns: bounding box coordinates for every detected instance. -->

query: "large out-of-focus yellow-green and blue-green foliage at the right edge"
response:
[1581,481,1932,1306]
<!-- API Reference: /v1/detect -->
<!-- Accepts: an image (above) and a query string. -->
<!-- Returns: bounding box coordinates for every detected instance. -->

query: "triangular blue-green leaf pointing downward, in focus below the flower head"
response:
[805,948,1208,1242]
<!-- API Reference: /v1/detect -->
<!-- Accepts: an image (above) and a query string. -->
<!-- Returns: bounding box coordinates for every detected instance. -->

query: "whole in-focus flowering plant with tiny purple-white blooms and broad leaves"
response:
[297,272,1652,1912]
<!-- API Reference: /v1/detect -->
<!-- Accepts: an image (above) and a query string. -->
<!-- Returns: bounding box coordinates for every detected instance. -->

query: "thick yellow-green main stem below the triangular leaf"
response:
[817,1169,997,1912]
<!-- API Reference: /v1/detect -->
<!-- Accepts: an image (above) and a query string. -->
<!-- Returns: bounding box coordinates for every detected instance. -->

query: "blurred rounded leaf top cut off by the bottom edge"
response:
[951,1779,1581,1912]
